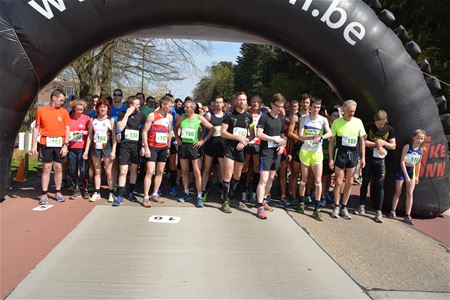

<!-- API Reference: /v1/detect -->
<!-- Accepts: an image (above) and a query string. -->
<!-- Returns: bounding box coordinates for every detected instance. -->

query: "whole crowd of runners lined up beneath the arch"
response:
[32,89,425,224]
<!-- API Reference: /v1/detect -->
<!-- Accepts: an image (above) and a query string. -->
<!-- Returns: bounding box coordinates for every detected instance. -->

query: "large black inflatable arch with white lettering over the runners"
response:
[0,0,450,217]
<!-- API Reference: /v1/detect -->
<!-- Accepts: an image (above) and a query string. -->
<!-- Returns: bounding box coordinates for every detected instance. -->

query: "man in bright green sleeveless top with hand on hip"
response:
[175,100,214,208]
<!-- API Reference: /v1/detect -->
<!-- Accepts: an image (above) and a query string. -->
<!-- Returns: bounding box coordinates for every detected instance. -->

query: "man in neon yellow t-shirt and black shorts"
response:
[329,100,366,220]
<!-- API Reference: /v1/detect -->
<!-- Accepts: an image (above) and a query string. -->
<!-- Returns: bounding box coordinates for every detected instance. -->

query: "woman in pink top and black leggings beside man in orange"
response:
[68,100,91,199]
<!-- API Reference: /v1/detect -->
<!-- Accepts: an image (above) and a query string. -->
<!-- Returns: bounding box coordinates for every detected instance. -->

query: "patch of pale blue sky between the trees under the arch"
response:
[164,42,241,99]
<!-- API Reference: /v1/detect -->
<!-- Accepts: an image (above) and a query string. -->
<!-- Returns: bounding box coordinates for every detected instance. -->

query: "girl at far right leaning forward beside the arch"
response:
[389,129,426,225]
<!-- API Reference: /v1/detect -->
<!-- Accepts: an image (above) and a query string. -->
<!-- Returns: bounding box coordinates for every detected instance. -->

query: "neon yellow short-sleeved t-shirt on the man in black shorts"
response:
[331,117,366,148]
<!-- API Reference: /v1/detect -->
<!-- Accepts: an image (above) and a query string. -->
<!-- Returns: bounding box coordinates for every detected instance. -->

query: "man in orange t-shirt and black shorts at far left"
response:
[31,89,70,205]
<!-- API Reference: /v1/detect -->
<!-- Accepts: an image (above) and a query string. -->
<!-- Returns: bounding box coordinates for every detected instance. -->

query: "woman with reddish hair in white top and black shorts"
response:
[83,99,117,202]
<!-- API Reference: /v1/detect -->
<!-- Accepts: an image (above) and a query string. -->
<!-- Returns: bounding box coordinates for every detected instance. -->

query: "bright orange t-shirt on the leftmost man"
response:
[36,105,70,145]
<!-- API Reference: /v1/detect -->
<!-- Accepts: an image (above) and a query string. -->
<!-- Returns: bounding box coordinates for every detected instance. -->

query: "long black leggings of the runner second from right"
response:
[359,159,386,210]
